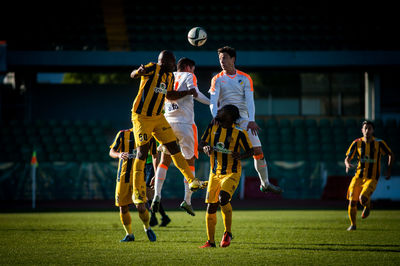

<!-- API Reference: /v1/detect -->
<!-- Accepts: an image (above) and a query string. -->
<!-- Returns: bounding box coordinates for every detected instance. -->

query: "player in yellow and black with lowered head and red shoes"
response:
[200,105,254,248]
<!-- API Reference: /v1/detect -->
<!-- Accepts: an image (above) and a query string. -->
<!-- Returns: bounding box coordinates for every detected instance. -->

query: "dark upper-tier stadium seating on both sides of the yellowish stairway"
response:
[7,0,399,51]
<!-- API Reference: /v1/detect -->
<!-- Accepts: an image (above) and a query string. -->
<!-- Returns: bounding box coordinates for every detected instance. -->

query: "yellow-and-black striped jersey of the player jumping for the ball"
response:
[132,63,174,116]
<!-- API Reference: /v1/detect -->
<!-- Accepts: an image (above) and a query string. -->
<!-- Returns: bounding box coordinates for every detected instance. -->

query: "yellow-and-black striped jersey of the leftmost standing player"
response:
[110,129,157,183]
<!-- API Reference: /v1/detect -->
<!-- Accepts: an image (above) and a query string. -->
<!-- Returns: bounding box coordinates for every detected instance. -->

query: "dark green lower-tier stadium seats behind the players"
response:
[0,118,400,167]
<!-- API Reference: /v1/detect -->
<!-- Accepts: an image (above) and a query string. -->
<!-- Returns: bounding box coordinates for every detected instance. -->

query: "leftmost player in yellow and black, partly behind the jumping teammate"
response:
[109,129,157,242]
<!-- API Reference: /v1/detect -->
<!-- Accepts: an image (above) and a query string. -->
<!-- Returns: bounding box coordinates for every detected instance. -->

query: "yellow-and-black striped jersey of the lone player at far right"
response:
[346,137,392,180]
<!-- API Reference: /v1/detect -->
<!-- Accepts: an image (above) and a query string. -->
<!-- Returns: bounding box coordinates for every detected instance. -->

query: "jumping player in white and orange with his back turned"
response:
[151,57,210,216]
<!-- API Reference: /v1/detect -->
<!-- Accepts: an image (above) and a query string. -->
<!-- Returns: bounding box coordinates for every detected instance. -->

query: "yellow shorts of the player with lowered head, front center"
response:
[205,171,241,203]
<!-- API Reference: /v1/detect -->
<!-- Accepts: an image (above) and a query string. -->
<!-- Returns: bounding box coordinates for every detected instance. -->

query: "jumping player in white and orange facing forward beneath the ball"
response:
[209,46,282,194]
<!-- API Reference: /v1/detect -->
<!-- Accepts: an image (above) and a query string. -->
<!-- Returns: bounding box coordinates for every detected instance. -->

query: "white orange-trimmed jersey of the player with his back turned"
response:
[164,72,210,124]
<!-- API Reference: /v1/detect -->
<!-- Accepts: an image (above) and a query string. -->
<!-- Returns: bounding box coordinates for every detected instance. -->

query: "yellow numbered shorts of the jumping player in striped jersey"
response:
[132,113,176,146]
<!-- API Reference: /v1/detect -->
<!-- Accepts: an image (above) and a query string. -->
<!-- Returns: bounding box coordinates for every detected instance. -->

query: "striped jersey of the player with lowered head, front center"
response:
[201,124,253,175]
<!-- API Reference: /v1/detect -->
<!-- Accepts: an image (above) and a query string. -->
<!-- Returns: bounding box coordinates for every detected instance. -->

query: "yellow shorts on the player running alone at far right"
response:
[347,177,378,201]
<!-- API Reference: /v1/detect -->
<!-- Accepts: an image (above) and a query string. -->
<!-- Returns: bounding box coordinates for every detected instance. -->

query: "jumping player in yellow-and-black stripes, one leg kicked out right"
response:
[131,50,207,227]
